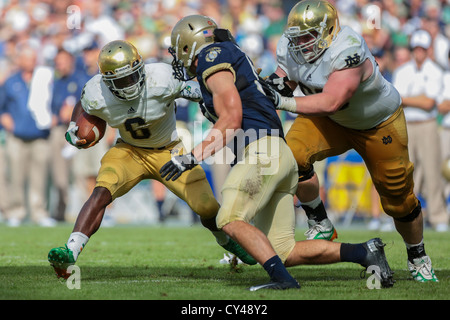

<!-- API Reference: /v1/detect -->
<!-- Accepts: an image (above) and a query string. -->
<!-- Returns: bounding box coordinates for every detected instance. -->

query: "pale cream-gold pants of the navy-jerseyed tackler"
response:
[216,136,297,262]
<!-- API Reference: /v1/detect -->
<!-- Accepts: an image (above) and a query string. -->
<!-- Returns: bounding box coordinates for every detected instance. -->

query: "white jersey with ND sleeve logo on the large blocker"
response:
[277,26,401,130]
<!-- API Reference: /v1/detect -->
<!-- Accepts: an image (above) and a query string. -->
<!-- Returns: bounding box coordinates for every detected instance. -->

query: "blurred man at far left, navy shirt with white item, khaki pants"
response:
[0,44,55,226]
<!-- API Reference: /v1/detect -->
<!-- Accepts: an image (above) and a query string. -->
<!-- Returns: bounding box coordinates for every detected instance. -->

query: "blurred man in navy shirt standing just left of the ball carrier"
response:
[50,50,85,221]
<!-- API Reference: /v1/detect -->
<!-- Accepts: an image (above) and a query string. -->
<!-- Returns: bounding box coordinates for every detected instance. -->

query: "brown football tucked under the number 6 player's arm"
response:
[76,111,106,149]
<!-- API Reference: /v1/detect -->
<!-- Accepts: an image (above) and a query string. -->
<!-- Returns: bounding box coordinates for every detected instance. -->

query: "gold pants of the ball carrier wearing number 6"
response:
[96,140,219,219]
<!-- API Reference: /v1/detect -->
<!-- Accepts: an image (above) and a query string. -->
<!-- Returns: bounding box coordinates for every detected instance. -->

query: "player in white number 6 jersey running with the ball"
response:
[48,40,256,278]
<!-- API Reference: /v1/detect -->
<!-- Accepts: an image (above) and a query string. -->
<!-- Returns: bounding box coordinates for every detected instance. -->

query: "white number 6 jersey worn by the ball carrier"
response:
[81,63,201,148]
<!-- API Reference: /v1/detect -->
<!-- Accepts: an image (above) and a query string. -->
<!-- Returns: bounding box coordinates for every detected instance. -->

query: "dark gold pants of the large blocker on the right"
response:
[286,108,418,218]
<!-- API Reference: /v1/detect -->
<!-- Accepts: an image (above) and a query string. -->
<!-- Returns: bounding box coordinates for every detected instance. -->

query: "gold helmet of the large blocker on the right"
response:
[284,0,340,64]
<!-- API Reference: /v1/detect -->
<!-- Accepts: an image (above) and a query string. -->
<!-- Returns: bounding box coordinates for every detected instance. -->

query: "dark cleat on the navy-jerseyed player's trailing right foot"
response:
[361,238,395,288]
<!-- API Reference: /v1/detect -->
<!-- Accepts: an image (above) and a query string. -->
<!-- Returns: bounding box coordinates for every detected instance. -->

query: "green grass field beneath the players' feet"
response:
[0,225,450,302]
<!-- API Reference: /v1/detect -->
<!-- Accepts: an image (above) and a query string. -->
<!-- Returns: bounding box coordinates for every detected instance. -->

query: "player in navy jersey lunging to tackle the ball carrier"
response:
[160,15,394,291]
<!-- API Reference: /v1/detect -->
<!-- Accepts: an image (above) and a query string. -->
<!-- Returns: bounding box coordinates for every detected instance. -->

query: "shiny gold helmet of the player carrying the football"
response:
[98,40,145,101]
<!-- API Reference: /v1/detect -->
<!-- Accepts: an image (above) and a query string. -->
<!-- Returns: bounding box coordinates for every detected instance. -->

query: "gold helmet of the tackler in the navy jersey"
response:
[169,15,217,79]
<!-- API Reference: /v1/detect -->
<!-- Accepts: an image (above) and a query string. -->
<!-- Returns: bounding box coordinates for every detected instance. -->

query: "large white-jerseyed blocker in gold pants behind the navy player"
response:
[263,0,437,281]
